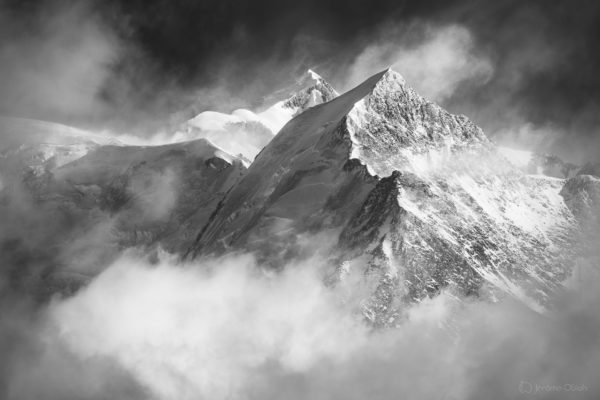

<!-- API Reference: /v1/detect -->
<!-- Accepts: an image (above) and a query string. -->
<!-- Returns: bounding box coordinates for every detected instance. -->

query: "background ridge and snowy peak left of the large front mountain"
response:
[0,71,337,297]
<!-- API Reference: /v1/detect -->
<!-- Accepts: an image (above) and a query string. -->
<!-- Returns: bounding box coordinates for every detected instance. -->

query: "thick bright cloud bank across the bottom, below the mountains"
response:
[5,248,600,399]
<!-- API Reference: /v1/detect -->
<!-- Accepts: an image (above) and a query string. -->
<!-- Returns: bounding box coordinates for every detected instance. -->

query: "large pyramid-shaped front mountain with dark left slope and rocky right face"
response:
[188,70,576,318]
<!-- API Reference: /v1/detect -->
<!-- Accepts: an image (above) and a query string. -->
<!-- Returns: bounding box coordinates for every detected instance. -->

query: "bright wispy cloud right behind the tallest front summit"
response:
[348,24,494,102]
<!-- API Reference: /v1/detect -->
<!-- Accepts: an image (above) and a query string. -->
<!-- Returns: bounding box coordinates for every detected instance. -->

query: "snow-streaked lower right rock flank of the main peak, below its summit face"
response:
[340,160,573,316]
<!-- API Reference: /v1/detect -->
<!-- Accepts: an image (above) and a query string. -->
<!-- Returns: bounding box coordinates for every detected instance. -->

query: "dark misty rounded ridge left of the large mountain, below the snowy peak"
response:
[0,140,246,292]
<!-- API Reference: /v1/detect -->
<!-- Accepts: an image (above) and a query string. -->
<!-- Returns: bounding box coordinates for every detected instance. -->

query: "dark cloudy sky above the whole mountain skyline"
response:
[0,0,600,159]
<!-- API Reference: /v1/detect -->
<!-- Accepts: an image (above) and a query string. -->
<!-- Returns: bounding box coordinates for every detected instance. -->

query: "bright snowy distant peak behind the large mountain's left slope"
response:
[174,70,338,163]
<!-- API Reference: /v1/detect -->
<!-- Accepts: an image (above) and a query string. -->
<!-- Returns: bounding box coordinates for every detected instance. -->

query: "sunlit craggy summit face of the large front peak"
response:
[346,69,490,176]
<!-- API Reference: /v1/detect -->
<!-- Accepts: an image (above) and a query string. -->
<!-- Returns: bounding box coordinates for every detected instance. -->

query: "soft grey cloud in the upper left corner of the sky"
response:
[0,2,120,120]
